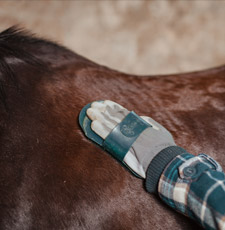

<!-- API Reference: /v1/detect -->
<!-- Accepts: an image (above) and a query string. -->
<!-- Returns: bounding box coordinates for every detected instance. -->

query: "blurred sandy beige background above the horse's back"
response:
[0,0,225,74]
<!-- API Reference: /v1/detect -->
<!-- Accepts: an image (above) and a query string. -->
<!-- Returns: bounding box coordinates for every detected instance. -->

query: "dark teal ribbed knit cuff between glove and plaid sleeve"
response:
[145,146,187,193]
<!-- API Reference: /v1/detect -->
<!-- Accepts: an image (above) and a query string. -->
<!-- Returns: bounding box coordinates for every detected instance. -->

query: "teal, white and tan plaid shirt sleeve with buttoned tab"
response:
[158,153,225,230]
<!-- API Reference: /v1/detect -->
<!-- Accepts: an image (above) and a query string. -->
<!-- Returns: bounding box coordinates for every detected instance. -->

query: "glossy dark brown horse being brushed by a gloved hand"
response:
[0,28,225,230]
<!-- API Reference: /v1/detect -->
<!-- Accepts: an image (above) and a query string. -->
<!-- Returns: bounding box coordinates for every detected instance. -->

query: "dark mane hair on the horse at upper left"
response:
[0,26,64,108]
